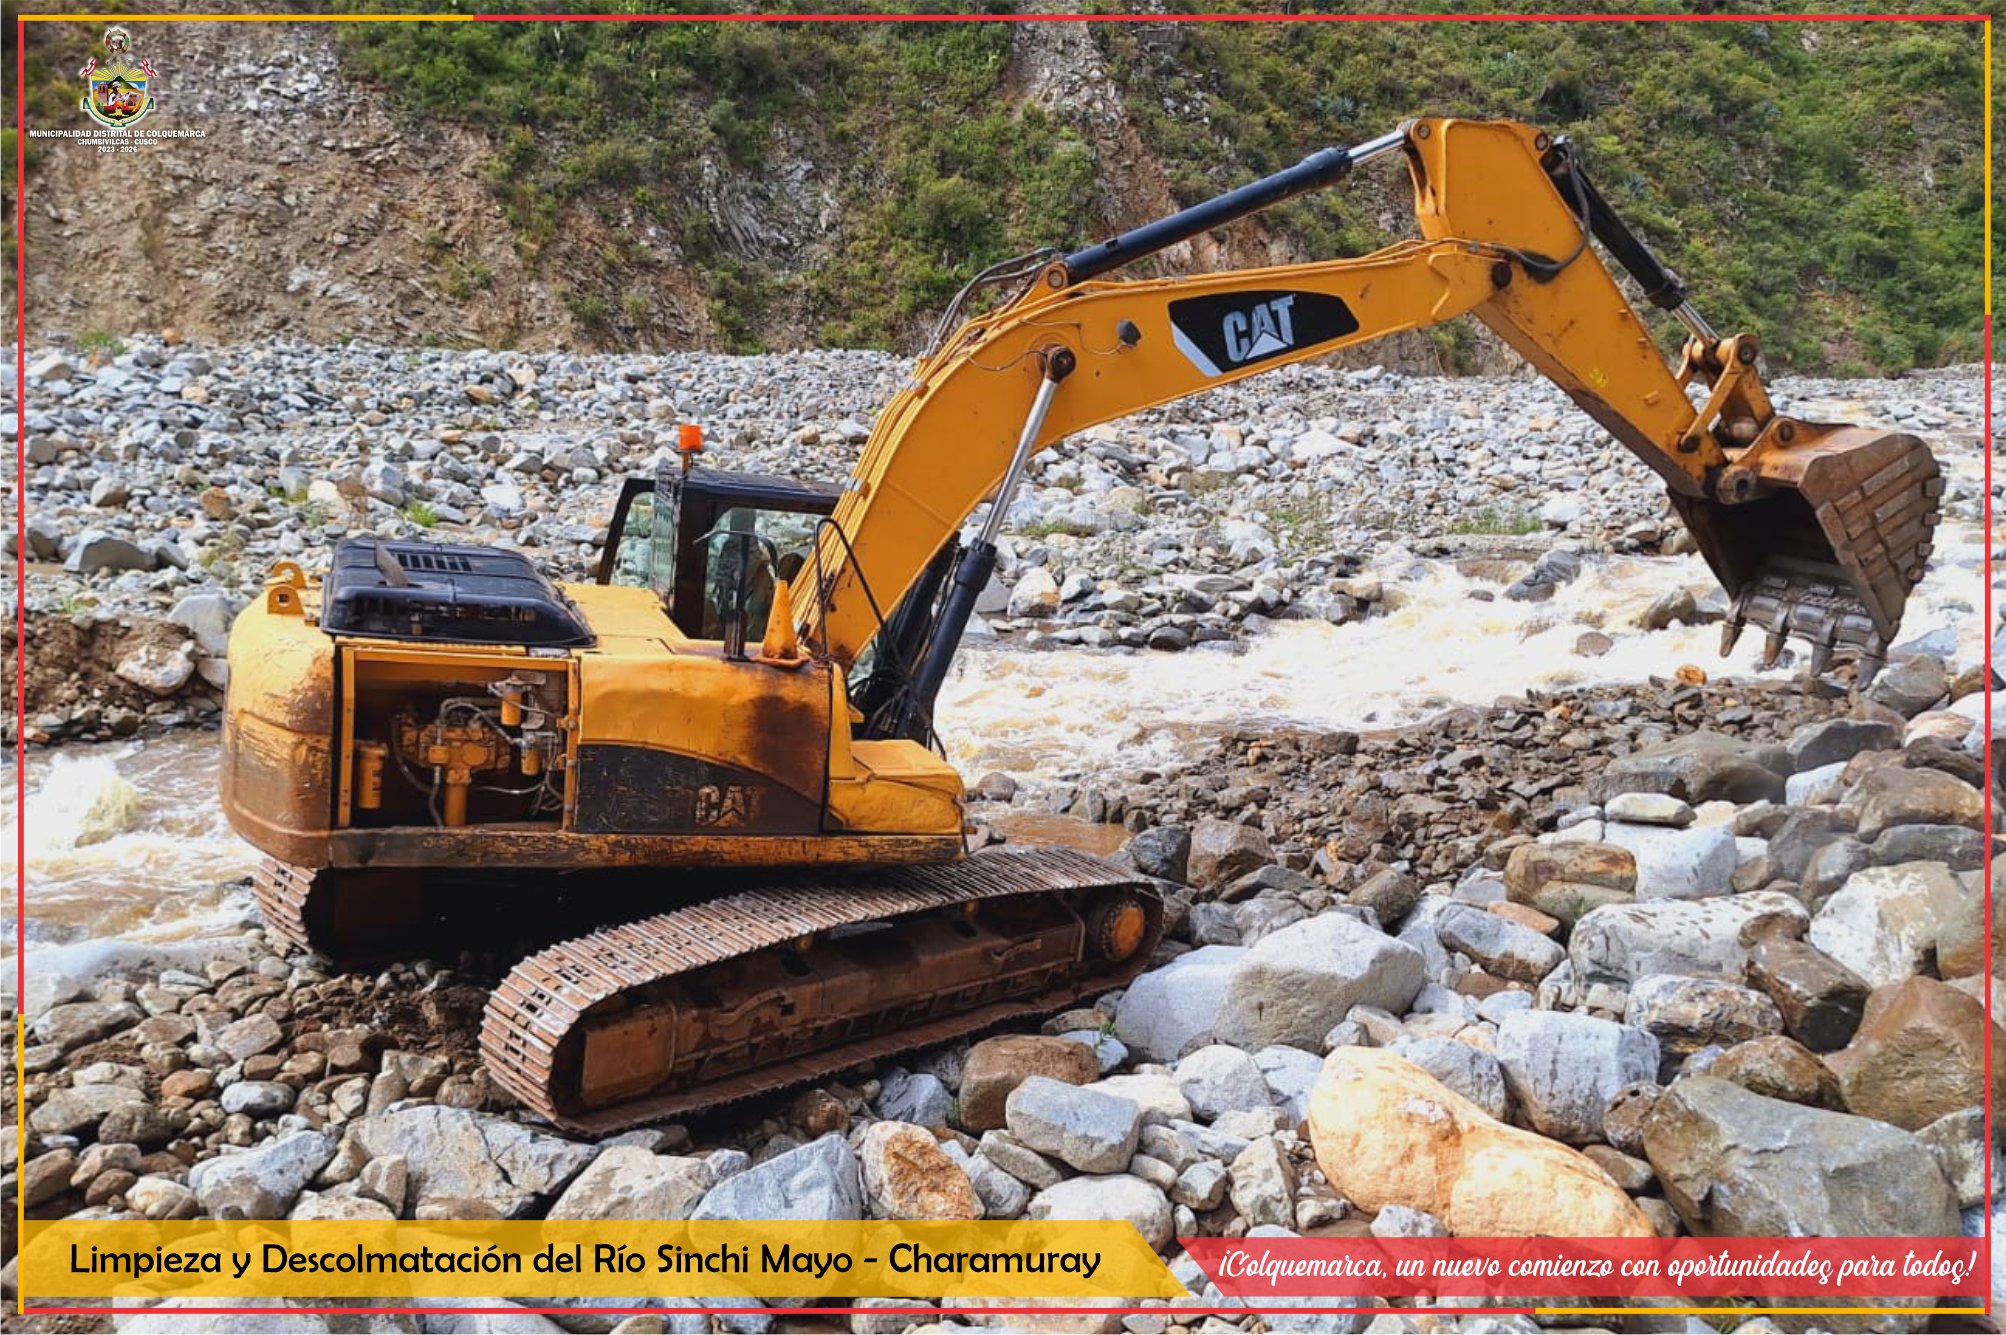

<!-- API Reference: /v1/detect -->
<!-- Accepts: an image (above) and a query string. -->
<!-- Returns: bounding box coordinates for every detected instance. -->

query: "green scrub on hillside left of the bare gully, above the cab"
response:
[341,0,1097,351]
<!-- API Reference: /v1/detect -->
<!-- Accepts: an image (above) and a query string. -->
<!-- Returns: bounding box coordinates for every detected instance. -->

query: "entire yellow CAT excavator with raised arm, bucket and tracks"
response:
[223,118,1942,1131]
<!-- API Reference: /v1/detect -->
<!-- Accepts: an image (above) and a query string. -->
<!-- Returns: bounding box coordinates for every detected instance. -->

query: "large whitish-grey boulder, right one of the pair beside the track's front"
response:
[1203,914,1426,1050]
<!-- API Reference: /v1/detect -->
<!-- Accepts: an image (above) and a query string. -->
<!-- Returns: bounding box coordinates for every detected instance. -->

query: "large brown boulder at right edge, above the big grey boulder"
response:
[1825,978,2006,1131]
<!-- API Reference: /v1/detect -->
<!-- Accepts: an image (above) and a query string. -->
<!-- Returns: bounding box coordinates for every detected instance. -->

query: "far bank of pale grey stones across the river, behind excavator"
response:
[0,333,1982,740]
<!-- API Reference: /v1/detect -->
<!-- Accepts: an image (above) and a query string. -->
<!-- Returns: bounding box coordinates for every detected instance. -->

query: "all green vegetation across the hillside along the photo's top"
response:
[6,0,1984,373]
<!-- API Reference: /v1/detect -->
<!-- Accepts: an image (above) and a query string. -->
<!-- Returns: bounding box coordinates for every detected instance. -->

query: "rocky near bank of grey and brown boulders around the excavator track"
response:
[8,641,1996,1331]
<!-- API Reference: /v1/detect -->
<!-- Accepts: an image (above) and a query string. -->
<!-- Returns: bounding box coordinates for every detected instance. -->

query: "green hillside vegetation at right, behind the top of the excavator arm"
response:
[1093,0,1984,373]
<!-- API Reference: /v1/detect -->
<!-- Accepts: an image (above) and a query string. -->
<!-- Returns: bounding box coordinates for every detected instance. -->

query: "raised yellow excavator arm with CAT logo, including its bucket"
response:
[792,118,1942,714]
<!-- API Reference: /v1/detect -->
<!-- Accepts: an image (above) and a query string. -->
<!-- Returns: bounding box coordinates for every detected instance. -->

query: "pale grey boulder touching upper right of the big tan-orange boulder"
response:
[1496,1010,1659,1145]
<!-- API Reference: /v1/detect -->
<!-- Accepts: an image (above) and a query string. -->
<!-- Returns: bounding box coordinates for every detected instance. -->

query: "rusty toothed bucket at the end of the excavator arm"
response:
[1673,423,1944,682]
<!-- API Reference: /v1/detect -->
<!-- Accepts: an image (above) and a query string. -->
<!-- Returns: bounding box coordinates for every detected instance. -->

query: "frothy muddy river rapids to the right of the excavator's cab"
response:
[937,525,1984,782]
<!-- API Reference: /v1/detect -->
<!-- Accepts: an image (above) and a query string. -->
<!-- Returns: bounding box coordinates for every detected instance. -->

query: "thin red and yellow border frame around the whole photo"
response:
[14,12,1994,1329]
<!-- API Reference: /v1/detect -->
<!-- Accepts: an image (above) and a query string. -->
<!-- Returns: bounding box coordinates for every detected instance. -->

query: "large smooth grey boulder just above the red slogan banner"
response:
[1643,1076,1958,1237]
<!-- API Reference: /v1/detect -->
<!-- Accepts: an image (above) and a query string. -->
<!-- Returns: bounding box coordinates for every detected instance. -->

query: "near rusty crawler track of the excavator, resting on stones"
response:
[481,848,1163,1133]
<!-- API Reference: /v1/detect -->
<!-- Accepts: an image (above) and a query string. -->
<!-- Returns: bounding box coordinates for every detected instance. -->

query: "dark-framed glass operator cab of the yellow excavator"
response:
[596,463,843,643]
